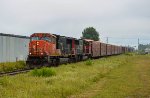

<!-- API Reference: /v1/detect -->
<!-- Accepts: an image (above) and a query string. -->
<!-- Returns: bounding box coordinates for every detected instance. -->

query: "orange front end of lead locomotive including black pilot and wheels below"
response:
[26,33,59,66]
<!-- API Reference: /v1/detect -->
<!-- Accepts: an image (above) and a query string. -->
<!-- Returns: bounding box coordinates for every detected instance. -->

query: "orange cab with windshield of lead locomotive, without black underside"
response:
[29,33,56,56]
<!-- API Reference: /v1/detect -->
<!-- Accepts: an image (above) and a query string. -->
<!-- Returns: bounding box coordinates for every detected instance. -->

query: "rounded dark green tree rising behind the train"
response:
[82,27,99,41]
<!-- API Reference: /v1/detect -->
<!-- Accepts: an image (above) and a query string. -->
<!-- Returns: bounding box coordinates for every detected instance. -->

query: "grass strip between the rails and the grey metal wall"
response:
[0,61,26,72]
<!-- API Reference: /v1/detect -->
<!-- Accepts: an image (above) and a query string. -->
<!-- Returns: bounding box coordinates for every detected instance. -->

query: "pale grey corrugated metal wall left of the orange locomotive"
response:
[0,34,30,62]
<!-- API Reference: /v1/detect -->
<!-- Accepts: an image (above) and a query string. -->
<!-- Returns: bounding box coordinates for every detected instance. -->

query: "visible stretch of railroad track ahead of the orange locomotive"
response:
[0,69,32,77]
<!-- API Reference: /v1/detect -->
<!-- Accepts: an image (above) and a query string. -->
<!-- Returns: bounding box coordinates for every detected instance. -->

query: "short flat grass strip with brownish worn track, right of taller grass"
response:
[69,56,150,98]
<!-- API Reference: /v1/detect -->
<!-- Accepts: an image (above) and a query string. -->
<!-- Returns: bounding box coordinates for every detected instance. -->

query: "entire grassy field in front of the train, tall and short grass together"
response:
[0,55,150,98]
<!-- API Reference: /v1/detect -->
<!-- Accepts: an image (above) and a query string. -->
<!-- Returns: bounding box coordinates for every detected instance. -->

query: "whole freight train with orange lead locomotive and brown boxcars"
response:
[26,33,133,67]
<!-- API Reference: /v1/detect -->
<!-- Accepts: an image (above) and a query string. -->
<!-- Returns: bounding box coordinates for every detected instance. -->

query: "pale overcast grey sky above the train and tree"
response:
[0,0,150,45]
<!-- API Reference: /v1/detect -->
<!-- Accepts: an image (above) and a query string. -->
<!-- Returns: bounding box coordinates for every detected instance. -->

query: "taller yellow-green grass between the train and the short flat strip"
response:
[0,55,137,98]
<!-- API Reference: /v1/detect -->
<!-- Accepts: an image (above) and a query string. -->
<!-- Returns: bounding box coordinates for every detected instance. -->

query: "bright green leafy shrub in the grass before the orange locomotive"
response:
[31,67,56,77]
